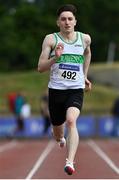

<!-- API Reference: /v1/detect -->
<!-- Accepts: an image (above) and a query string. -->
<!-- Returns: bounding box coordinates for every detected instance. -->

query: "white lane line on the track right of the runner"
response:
[87,140,119,174]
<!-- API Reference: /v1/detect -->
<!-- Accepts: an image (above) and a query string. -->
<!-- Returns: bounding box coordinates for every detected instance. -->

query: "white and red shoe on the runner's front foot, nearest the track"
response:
[64,159,75,175]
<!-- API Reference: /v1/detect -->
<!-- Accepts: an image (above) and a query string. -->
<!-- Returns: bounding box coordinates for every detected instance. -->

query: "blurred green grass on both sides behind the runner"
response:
[0,65,119,115]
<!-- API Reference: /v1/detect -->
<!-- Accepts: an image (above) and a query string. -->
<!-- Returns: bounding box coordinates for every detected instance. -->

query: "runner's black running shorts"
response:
[49,88,84,126]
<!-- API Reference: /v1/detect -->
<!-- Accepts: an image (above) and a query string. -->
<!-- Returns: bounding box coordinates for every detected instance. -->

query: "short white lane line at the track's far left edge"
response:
[0,140,17,153]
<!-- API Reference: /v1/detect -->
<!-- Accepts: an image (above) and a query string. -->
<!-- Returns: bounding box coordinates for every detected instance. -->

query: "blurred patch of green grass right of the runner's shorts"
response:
[83,84,119,115]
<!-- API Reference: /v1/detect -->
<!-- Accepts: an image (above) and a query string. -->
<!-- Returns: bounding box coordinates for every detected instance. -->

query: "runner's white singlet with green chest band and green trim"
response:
[48,32,85,90]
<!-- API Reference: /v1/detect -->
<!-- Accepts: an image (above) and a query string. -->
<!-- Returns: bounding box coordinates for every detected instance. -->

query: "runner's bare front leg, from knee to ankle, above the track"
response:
[66,107,80,163]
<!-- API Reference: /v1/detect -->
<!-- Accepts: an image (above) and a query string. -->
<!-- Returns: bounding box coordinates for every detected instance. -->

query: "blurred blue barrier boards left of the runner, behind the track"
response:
[0,117,51,138]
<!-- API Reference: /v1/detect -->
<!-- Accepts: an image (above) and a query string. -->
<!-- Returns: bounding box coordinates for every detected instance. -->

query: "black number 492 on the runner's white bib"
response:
[61,71,76,81]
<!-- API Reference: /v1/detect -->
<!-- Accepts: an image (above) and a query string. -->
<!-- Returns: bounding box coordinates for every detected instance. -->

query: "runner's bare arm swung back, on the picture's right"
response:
[83,34,91,90]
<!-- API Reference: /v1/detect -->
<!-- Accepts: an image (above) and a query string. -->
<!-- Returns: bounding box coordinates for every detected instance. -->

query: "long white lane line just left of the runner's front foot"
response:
[25,141,55,180]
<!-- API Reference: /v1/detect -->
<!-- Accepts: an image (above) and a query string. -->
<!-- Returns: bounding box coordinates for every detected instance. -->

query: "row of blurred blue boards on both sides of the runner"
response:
[0,116,117,138]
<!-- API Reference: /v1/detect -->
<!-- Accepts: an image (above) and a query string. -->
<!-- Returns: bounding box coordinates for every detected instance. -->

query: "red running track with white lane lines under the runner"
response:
[0,139,119,179]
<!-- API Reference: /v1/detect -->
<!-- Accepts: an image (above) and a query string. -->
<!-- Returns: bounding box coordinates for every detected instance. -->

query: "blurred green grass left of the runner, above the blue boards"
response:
[0,71,48,114]
